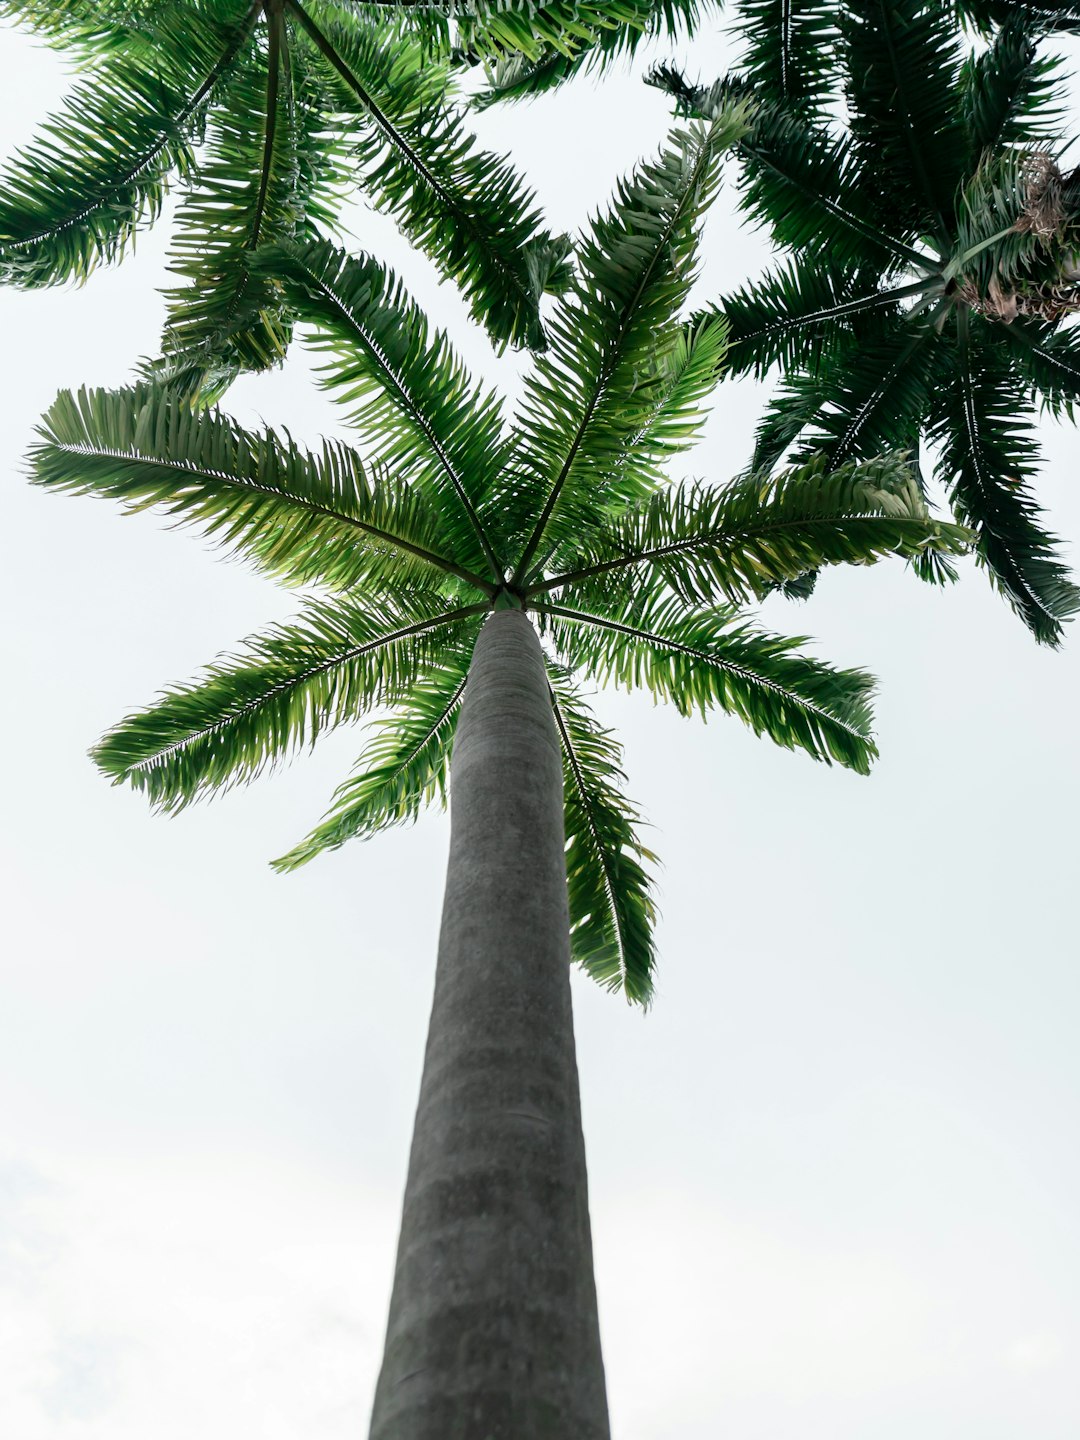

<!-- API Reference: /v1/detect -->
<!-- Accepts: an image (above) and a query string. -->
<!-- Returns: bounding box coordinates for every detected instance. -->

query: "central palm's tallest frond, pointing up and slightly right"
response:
[516,107,744,582]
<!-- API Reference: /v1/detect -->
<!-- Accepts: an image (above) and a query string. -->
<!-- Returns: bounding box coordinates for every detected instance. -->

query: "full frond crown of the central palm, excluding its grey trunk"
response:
[33,107,963,1001]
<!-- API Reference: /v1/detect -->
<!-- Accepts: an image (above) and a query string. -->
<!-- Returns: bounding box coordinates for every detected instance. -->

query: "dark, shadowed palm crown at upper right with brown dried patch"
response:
[654,0,1080,644]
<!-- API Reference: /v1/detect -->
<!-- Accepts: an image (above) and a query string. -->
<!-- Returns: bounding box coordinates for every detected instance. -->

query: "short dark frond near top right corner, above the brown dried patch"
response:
[959,14,1063,156]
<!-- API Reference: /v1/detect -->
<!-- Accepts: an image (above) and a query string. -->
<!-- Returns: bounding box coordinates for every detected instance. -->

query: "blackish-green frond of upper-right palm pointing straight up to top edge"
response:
[841,0,966,251]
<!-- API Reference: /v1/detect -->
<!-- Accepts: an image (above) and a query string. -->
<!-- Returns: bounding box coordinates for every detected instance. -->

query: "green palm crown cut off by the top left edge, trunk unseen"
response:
[0,0,720,383]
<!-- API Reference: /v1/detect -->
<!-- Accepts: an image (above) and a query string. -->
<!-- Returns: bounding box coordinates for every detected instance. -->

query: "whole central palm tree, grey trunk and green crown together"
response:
[33,107,963,1440]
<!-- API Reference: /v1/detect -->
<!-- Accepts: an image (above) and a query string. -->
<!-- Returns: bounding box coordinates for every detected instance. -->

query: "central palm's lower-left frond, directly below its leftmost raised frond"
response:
[94,590,487,811]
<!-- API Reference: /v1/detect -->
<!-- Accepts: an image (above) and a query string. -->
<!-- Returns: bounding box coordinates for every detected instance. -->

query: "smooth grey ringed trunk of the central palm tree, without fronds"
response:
[370,611,609,1440]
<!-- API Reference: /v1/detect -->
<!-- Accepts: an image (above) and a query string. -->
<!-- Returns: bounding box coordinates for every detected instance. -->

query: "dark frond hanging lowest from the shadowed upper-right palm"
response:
[930,324,1080,645]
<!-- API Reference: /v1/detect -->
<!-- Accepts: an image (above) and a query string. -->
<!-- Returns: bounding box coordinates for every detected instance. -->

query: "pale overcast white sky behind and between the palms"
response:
[0,11,1080,1440]
